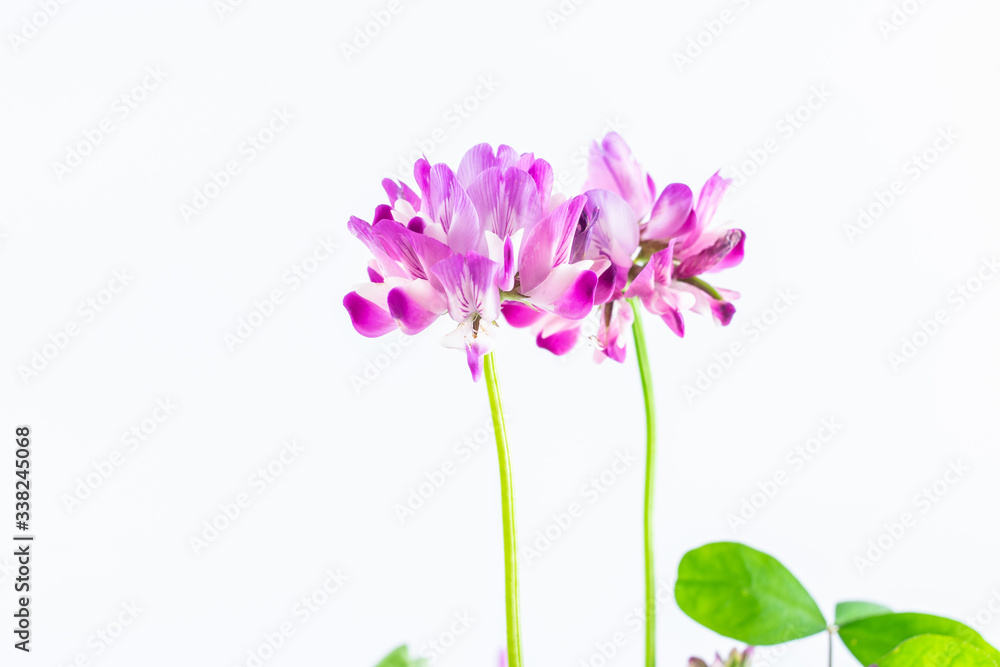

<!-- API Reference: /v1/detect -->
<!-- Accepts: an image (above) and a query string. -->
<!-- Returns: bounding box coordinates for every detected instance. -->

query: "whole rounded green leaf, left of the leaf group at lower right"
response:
[674,542,826,646]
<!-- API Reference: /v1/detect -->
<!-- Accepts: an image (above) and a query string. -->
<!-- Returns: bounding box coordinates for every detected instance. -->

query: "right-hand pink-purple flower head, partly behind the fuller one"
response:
[503,133,745,361]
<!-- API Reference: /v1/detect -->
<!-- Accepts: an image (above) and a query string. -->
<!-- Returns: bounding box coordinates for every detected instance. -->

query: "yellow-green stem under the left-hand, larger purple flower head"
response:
[483,352,522,667]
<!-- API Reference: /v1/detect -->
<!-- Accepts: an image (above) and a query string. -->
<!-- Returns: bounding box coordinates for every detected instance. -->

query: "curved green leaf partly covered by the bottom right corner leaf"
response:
[840,613,1000,665]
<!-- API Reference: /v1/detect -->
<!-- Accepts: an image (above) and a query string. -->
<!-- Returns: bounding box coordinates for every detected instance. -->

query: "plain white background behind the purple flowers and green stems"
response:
[0,0,1000,667]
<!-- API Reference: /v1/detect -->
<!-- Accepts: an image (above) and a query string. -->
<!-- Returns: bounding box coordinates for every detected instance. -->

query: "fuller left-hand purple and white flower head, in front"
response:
[344,144,592,379]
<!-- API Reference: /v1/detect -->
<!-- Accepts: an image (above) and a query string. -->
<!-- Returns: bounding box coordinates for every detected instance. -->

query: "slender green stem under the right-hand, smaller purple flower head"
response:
[629,299,656,667]
